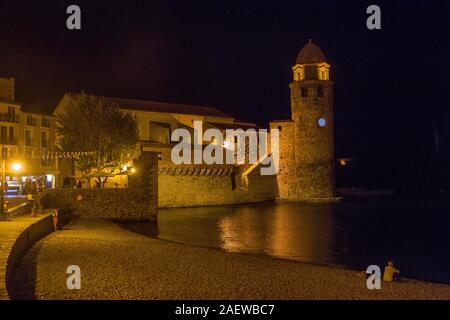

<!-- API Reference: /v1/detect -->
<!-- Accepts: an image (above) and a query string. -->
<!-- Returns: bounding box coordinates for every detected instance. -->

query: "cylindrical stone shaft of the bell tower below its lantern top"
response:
[291,80,334,200]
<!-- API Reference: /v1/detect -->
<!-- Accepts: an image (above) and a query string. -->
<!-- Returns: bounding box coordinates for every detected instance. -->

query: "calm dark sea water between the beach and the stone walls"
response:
[127,200,450,284]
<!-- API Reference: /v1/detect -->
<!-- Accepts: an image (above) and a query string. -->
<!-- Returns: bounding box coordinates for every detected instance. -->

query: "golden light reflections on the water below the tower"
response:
[218,203,335,263]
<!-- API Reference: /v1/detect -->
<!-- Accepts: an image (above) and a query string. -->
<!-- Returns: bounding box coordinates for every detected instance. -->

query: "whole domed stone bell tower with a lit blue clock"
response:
[289,40,335,200]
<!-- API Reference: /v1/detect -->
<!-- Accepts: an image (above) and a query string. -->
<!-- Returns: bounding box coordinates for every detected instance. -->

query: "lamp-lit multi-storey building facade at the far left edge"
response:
[0,78,59,187]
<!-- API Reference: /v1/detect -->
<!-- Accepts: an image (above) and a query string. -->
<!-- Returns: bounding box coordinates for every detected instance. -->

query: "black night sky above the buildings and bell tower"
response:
[0,0,450,189]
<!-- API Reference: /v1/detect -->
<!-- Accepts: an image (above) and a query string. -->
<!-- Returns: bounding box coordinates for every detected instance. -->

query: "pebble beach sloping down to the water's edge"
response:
[12,220,450,300]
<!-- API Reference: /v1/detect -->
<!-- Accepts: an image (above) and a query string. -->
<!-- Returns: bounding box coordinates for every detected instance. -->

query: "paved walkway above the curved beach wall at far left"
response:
[0,214,48,299]
